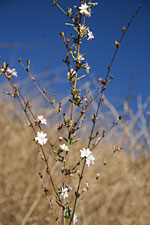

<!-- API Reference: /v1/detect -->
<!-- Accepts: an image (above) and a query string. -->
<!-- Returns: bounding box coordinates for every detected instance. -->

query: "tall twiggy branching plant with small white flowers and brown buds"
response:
[0,0,141,225]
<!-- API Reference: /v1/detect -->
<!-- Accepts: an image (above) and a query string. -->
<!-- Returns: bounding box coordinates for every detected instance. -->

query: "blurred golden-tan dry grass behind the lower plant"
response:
[0,101,150,225]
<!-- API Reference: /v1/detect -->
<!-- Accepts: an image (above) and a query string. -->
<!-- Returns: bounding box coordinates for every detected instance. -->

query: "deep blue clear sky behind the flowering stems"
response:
[0,0,150,108]
